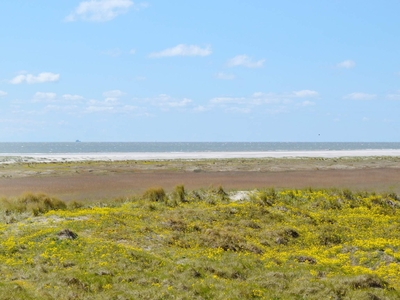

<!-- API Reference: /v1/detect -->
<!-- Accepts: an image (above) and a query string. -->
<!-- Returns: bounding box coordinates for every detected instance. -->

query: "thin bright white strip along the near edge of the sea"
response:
[0,149,400,164]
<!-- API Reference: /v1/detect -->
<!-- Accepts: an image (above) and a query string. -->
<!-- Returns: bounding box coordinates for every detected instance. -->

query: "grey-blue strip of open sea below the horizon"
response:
[0,142,400,154]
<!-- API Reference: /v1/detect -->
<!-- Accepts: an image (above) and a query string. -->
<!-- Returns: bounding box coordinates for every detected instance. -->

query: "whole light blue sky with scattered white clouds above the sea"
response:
[0,0,400,142]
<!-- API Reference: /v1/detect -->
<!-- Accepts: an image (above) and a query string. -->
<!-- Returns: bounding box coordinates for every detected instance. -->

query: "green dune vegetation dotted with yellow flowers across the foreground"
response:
[0,186,400,299]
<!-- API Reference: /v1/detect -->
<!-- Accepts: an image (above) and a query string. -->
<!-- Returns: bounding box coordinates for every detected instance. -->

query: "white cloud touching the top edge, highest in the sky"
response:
[65,0,135,22]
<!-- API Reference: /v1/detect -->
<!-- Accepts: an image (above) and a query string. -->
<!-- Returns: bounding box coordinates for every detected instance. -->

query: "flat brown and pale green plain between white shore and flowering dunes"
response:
[0,157,400,201]
